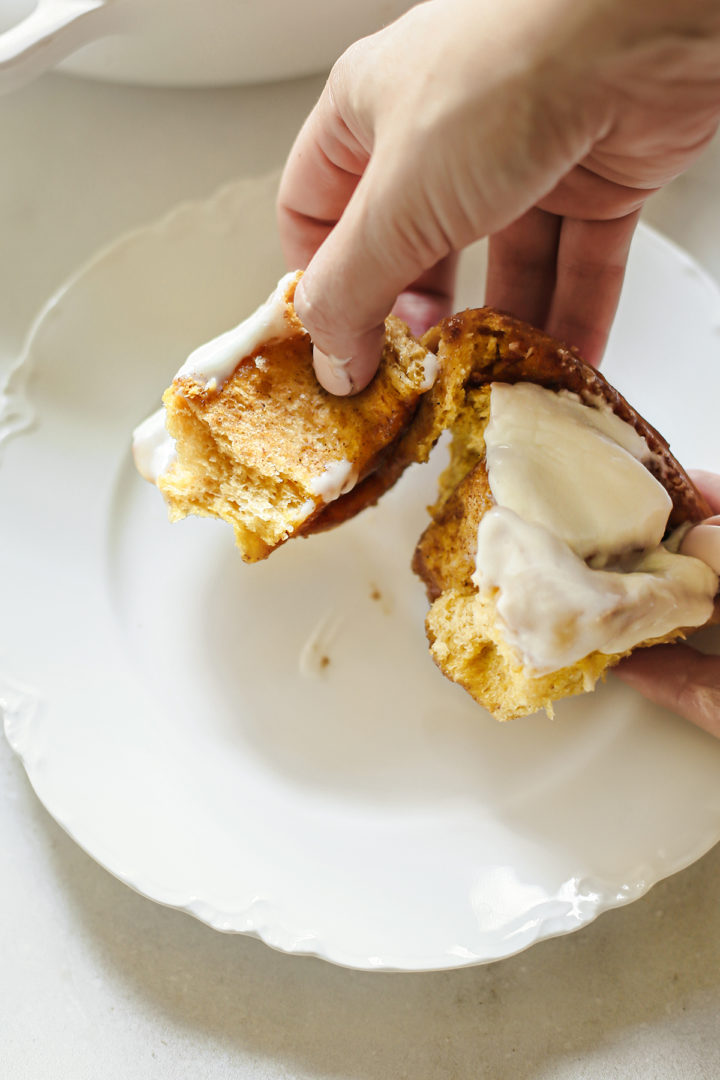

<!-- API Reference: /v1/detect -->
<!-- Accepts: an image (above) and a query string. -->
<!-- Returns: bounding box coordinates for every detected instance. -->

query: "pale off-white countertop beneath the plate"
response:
[0,77,720,1080]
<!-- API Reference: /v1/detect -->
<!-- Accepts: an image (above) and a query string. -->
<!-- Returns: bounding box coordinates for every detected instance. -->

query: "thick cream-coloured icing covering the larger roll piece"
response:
[473,383,718,674]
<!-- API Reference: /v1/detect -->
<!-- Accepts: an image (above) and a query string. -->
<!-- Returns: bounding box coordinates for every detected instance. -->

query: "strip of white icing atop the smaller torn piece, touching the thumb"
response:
[175,270,300,390]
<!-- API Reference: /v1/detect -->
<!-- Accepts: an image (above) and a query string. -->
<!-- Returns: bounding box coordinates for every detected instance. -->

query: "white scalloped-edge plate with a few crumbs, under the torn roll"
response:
[0,177,720,970]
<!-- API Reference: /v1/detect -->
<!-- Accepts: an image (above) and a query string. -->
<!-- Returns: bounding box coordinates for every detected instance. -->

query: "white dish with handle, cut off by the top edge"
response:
[0,0,411,91]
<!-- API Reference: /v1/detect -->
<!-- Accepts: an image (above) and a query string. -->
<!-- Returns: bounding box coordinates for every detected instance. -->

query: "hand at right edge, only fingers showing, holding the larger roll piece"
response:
[614,471,720,738]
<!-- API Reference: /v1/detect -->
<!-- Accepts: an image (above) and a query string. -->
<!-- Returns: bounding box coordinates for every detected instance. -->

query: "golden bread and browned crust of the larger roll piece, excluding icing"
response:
[406,308,710,719]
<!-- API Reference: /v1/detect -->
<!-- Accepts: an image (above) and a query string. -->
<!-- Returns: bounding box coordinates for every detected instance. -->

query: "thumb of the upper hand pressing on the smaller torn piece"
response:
[295,154,449,394]
